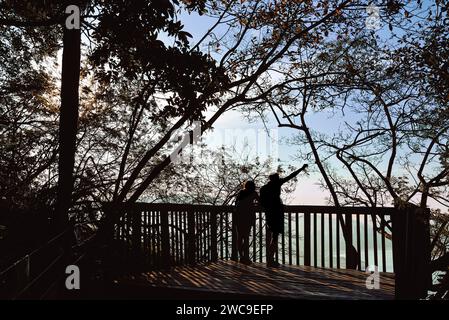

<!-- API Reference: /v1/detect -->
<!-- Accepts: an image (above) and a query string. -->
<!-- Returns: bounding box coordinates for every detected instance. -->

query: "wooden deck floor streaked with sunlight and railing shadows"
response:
[109,261,394,300]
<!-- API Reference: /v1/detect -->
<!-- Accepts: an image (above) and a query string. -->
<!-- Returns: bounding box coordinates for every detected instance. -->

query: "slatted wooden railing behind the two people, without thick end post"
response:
[115,203,402,272]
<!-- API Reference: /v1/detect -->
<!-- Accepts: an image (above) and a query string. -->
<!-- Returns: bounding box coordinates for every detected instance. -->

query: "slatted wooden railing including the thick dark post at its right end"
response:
[109,203,431,298]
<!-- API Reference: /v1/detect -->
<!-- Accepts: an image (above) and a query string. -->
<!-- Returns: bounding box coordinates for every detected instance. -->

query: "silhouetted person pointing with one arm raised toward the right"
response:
[260,164,307,267]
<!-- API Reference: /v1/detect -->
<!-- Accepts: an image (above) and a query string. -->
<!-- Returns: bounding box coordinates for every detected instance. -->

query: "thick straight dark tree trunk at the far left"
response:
[55,26,81,228]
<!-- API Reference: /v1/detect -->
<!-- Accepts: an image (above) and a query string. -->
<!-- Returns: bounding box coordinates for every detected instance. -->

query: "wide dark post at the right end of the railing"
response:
[391,205,432,299]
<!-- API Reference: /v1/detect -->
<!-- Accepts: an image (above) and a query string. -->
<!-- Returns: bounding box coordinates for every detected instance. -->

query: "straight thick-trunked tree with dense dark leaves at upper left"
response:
[0,0,222,225]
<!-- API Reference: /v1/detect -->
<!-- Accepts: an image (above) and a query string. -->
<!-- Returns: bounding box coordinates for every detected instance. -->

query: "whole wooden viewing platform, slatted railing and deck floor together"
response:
[0,204,431,300]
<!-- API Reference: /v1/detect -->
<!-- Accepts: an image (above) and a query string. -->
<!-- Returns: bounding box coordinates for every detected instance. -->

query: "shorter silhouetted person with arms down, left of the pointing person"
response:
[235,181,259,264]
